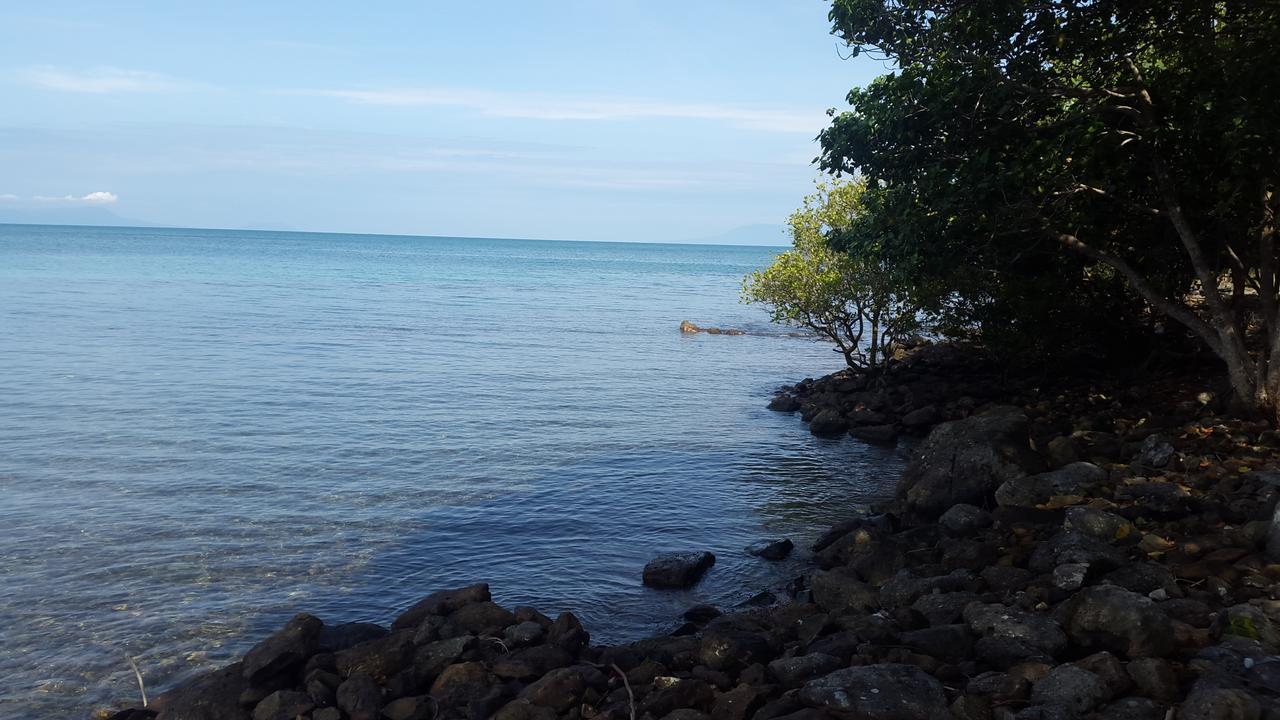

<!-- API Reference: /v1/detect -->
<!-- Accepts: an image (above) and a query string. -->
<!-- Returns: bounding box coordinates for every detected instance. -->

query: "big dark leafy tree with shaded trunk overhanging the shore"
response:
[820,0,1280,419]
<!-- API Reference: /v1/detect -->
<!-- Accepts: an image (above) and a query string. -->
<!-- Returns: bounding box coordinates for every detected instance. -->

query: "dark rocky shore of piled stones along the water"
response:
[102,346,1280,720]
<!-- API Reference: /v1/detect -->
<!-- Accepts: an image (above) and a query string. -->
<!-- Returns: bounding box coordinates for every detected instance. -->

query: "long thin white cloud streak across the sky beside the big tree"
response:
[292,88,827,133]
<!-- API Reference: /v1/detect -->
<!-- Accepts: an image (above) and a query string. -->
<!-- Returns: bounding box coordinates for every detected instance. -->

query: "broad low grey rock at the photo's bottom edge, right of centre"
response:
[800,664,947,720]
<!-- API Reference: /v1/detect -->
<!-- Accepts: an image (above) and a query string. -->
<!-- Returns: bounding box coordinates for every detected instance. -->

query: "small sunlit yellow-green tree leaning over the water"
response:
[742,181,920,369]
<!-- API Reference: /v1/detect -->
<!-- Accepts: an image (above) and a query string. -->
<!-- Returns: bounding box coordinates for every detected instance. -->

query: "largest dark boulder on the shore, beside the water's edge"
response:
[897,406,1033,519]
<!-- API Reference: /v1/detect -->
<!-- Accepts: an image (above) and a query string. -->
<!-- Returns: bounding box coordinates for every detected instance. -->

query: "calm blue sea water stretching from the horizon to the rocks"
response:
[0,225,900,719]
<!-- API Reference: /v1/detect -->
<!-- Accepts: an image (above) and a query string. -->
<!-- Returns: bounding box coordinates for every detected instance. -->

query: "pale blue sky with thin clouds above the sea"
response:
[0,0,884,241]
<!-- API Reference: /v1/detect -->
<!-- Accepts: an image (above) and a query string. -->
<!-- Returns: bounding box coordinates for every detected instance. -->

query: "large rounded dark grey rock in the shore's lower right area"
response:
[1060,585,1174,657]
